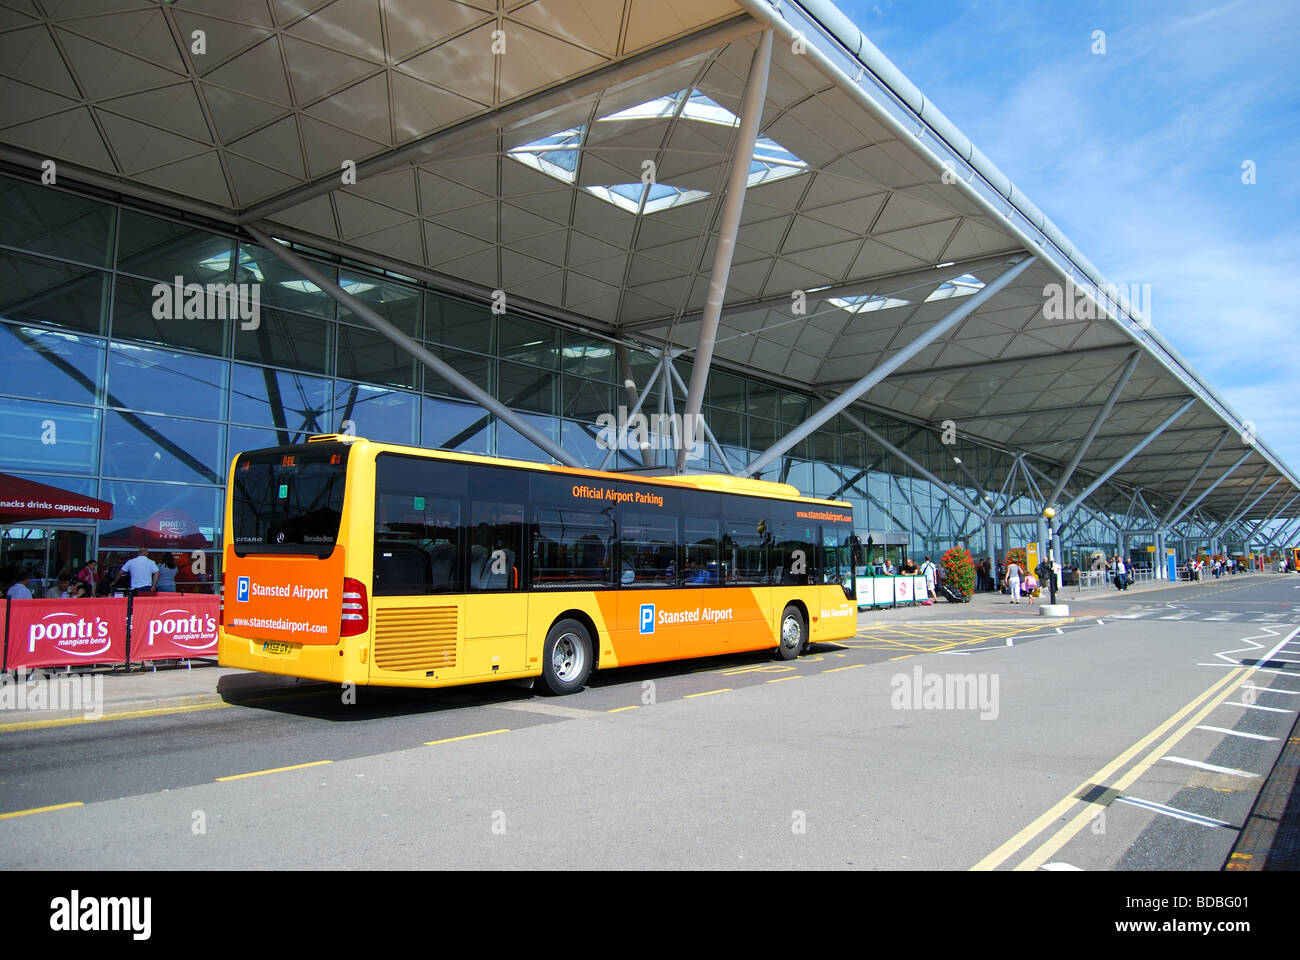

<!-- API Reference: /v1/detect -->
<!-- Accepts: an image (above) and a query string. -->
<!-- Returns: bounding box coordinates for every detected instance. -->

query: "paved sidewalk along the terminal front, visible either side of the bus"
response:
[0,574,1275,736]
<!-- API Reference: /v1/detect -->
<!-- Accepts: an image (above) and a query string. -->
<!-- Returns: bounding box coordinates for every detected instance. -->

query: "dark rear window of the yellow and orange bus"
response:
[231,444,348,557]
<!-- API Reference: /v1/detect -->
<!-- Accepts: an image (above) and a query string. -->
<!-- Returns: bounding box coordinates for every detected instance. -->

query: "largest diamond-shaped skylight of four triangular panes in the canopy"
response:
[508,90,807,215]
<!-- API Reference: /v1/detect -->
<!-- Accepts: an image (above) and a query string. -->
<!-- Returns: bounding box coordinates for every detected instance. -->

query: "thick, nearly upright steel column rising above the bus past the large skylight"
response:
[677,30,772,472]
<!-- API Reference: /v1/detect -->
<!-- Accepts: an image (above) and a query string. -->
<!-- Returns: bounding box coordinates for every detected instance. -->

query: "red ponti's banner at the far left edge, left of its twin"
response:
[4,597,126,670]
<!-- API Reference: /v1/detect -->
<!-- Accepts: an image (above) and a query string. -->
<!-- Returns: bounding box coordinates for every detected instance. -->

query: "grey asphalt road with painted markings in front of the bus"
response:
[0,578,1300,870]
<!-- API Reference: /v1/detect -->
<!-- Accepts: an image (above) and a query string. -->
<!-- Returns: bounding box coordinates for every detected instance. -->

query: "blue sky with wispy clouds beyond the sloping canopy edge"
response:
[837,0,1300,471]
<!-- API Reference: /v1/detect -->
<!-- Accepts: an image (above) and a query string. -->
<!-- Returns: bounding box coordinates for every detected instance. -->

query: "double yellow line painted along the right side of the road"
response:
[971,667,1257,870]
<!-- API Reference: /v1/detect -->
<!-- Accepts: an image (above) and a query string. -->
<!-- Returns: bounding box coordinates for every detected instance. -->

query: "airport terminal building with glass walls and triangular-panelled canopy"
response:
[0,0,1300,583]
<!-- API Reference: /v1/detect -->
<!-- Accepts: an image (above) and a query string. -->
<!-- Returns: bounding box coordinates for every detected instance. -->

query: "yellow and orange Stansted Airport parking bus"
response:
[220,434,859,695]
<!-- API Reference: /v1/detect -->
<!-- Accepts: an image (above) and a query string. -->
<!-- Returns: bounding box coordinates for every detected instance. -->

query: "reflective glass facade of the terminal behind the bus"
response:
[0,177,1149,584]
